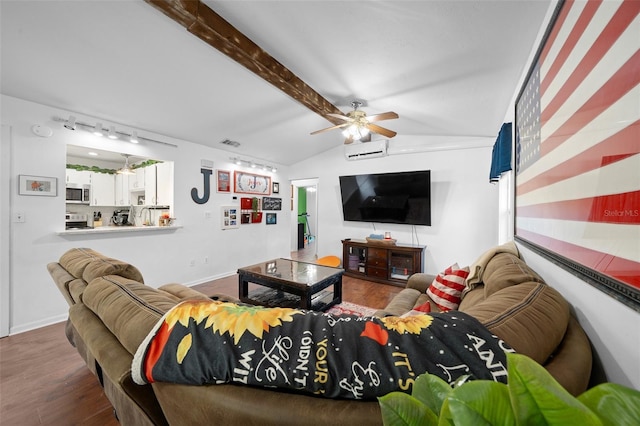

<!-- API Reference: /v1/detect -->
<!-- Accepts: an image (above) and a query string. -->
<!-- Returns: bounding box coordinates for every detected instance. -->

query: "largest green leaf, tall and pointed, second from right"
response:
[507,353,602,425]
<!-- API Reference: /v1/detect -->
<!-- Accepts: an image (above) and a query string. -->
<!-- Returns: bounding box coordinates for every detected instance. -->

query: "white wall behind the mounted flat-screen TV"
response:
[290,140,498,273]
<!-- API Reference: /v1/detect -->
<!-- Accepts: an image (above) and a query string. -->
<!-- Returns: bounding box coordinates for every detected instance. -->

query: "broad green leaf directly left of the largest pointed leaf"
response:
[447,380,516,426]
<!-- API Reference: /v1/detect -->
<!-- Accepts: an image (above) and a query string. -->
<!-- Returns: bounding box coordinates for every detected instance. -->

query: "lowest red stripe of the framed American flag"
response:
[516,228,640,288]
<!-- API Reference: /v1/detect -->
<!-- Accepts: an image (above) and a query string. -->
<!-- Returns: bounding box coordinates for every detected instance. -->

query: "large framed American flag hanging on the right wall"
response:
[514,1,640,312]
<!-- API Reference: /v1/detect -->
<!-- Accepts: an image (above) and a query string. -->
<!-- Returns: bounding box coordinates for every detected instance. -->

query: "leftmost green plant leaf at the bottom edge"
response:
[378,392,438,426]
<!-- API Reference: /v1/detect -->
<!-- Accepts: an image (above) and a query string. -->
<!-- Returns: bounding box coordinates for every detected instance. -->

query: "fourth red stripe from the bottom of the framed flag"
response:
[540,50,640,155]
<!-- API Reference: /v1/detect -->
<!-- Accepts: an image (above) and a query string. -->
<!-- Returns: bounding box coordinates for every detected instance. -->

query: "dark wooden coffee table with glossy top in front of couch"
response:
[238,259,344,311]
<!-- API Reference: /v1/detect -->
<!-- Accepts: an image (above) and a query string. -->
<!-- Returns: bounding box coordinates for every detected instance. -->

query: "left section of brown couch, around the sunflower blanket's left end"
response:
[47,248,382,426]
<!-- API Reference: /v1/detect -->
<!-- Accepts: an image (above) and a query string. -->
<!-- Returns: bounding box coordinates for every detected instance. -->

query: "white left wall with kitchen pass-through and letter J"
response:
[0,96,290,334]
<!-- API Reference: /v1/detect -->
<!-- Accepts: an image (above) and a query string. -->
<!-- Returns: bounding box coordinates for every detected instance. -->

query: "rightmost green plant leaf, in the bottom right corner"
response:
[578,383,640,425]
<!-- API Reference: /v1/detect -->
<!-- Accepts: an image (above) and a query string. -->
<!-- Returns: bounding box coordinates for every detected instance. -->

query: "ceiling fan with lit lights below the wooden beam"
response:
[311,101,398,144]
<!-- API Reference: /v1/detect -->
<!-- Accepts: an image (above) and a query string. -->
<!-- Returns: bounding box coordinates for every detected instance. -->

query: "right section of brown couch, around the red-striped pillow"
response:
[376,242,592,395]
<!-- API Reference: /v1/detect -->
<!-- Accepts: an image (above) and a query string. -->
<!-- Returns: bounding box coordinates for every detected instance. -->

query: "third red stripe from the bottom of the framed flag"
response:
[517,119,640,195]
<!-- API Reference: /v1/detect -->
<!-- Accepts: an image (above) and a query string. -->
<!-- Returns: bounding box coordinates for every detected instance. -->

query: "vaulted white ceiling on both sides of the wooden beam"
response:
[0,0,551,165]
